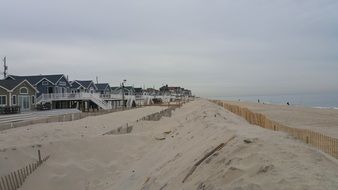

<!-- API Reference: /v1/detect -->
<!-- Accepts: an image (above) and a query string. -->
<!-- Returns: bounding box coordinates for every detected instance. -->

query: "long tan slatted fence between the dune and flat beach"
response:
[212,100,338,159]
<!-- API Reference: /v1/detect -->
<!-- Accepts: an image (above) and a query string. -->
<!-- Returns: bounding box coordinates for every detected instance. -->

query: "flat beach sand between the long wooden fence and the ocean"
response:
[226,101,338,138]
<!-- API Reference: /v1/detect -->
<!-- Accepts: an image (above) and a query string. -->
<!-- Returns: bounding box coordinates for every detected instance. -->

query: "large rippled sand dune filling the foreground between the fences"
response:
[0,100,338,190]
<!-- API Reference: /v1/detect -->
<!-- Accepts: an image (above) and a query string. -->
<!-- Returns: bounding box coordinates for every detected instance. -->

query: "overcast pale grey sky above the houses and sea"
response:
[0,0,338,97]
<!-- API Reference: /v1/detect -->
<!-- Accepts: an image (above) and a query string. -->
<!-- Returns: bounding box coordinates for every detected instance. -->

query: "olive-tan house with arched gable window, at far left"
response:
[0,79,38,111]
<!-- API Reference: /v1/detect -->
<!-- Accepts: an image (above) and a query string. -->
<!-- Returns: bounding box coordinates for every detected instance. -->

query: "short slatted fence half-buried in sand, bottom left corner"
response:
[0,150,49,190]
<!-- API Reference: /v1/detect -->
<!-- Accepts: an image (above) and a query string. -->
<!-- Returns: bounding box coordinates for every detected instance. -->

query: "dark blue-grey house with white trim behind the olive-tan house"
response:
[6,74,71,97]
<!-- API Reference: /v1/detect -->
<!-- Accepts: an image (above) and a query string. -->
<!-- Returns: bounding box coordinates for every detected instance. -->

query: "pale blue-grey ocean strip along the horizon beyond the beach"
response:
[212,92,338,109]
